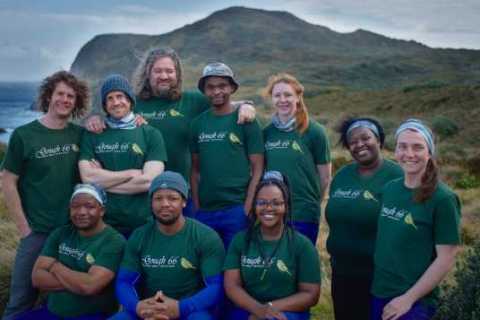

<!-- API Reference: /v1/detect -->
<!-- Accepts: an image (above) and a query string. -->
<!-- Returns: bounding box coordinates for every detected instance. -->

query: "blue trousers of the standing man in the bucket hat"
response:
[195,205,248,249]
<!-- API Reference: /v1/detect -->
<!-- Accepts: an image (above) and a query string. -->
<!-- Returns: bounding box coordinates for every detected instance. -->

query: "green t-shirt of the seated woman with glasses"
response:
[223,228,321,303]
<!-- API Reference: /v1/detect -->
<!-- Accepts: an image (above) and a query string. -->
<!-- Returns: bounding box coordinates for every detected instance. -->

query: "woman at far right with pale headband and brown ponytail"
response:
[372,119,460,320]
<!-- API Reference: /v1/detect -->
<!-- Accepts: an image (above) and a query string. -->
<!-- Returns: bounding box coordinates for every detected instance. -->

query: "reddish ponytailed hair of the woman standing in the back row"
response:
[263,73,309,133]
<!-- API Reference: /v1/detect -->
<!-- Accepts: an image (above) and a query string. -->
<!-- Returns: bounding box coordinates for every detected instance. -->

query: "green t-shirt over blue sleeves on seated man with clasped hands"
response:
[121,218,225,299]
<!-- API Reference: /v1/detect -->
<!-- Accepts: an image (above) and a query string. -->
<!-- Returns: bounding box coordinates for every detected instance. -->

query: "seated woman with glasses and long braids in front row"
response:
[224,171,321,320]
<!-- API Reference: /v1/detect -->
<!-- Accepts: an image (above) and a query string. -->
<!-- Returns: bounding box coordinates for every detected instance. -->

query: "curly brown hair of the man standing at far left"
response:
[36,70,90,119]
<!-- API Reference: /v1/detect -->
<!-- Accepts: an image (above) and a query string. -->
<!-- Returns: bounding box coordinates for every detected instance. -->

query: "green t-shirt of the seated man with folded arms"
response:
[40,225,125,317]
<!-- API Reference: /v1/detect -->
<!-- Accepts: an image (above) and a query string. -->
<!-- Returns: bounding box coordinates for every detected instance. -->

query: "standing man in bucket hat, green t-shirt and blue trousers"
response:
[190,62,264,247]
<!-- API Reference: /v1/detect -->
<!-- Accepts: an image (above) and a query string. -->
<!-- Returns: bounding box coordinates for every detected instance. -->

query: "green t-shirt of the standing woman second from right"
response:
[325,159,403,277]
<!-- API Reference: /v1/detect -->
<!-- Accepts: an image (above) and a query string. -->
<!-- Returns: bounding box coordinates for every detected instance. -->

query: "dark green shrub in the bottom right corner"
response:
[434,241,480,320]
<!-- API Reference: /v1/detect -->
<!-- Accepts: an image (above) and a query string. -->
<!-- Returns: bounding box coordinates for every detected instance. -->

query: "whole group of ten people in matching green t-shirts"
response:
[3,48,460,320]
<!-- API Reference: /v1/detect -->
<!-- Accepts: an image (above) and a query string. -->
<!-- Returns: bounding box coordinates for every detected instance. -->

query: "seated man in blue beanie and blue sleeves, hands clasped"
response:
[112,171,225,320]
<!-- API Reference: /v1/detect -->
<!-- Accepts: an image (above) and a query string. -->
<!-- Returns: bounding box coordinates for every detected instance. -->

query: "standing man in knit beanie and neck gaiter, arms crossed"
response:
[79,75,167,237]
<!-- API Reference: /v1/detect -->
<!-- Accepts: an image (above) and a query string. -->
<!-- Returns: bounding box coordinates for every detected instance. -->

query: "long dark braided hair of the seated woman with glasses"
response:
[245,175,293,252]
